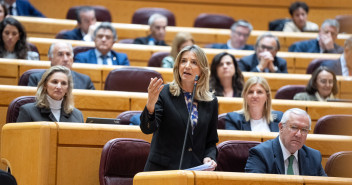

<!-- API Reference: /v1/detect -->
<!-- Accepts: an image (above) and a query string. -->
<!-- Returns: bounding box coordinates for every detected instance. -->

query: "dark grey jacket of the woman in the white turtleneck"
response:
[17,103,84,123]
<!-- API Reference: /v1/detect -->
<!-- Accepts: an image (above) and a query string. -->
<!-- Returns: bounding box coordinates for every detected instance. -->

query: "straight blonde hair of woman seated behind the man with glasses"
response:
[240,76,273,124]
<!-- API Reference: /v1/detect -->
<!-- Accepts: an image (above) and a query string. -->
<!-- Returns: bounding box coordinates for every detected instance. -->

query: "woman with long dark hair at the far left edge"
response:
[0,17,39,60]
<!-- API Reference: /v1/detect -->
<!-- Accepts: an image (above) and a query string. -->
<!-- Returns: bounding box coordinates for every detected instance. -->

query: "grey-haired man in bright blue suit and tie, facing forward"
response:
[75,22,130,66]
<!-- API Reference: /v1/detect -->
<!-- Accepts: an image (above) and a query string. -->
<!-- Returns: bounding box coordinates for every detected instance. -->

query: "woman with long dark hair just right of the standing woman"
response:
[210,52,244,97]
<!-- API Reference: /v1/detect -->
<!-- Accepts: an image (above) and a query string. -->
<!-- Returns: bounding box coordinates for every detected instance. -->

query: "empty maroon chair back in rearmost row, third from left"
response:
[193,13,235,29]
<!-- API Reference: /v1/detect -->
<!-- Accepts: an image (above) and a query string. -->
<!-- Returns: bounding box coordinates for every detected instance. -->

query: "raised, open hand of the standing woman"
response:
[147,77,164,114]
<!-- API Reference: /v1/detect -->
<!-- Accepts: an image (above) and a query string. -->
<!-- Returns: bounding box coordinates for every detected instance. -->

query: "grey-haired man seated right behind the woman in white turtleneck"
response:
[28,42,95,90]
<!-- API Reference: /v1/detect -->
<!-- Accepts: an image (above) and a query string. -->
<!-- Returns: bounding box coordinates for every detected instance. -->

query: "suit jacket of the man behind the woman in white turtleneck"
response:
[28,71,95,90]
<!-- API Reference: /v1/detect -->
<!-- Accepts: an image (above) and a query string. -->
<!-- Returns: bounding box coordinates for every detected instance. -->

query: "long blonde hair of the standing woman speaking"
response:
[170,45,214,101]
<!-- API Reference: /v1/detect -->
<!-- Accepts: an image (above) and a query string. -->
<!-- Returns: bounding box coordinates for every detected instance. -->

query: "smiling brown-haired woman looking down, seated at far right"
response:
[293,66,338,101]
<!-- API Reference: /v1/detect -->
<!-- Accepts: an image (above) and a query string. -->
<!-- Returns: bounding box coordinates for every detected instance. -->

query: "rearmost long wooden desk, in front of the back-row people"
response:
[16,16,351,51]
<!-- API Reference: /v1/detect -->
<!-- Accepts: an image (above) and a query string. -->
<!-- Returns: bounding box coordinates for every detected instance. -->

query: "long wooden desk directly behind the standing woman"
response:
[1,122,352,185]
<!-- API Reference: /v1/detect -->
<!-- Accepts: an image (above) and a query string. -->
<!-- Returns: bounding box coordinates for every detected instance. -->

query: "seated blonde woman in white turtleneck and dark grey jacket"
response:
[17,66,83,123]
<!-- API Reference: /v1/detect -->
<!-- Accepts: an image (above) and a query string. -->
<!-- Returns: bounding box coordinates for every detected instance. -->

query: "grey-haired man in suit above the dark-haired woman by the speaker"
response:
[211,20,254,50]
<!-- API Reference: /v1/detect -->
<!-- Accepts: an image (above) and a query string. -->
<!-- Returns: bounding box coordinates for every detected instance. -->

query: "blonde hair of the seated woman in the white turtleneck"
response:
[36,66,74,114]
